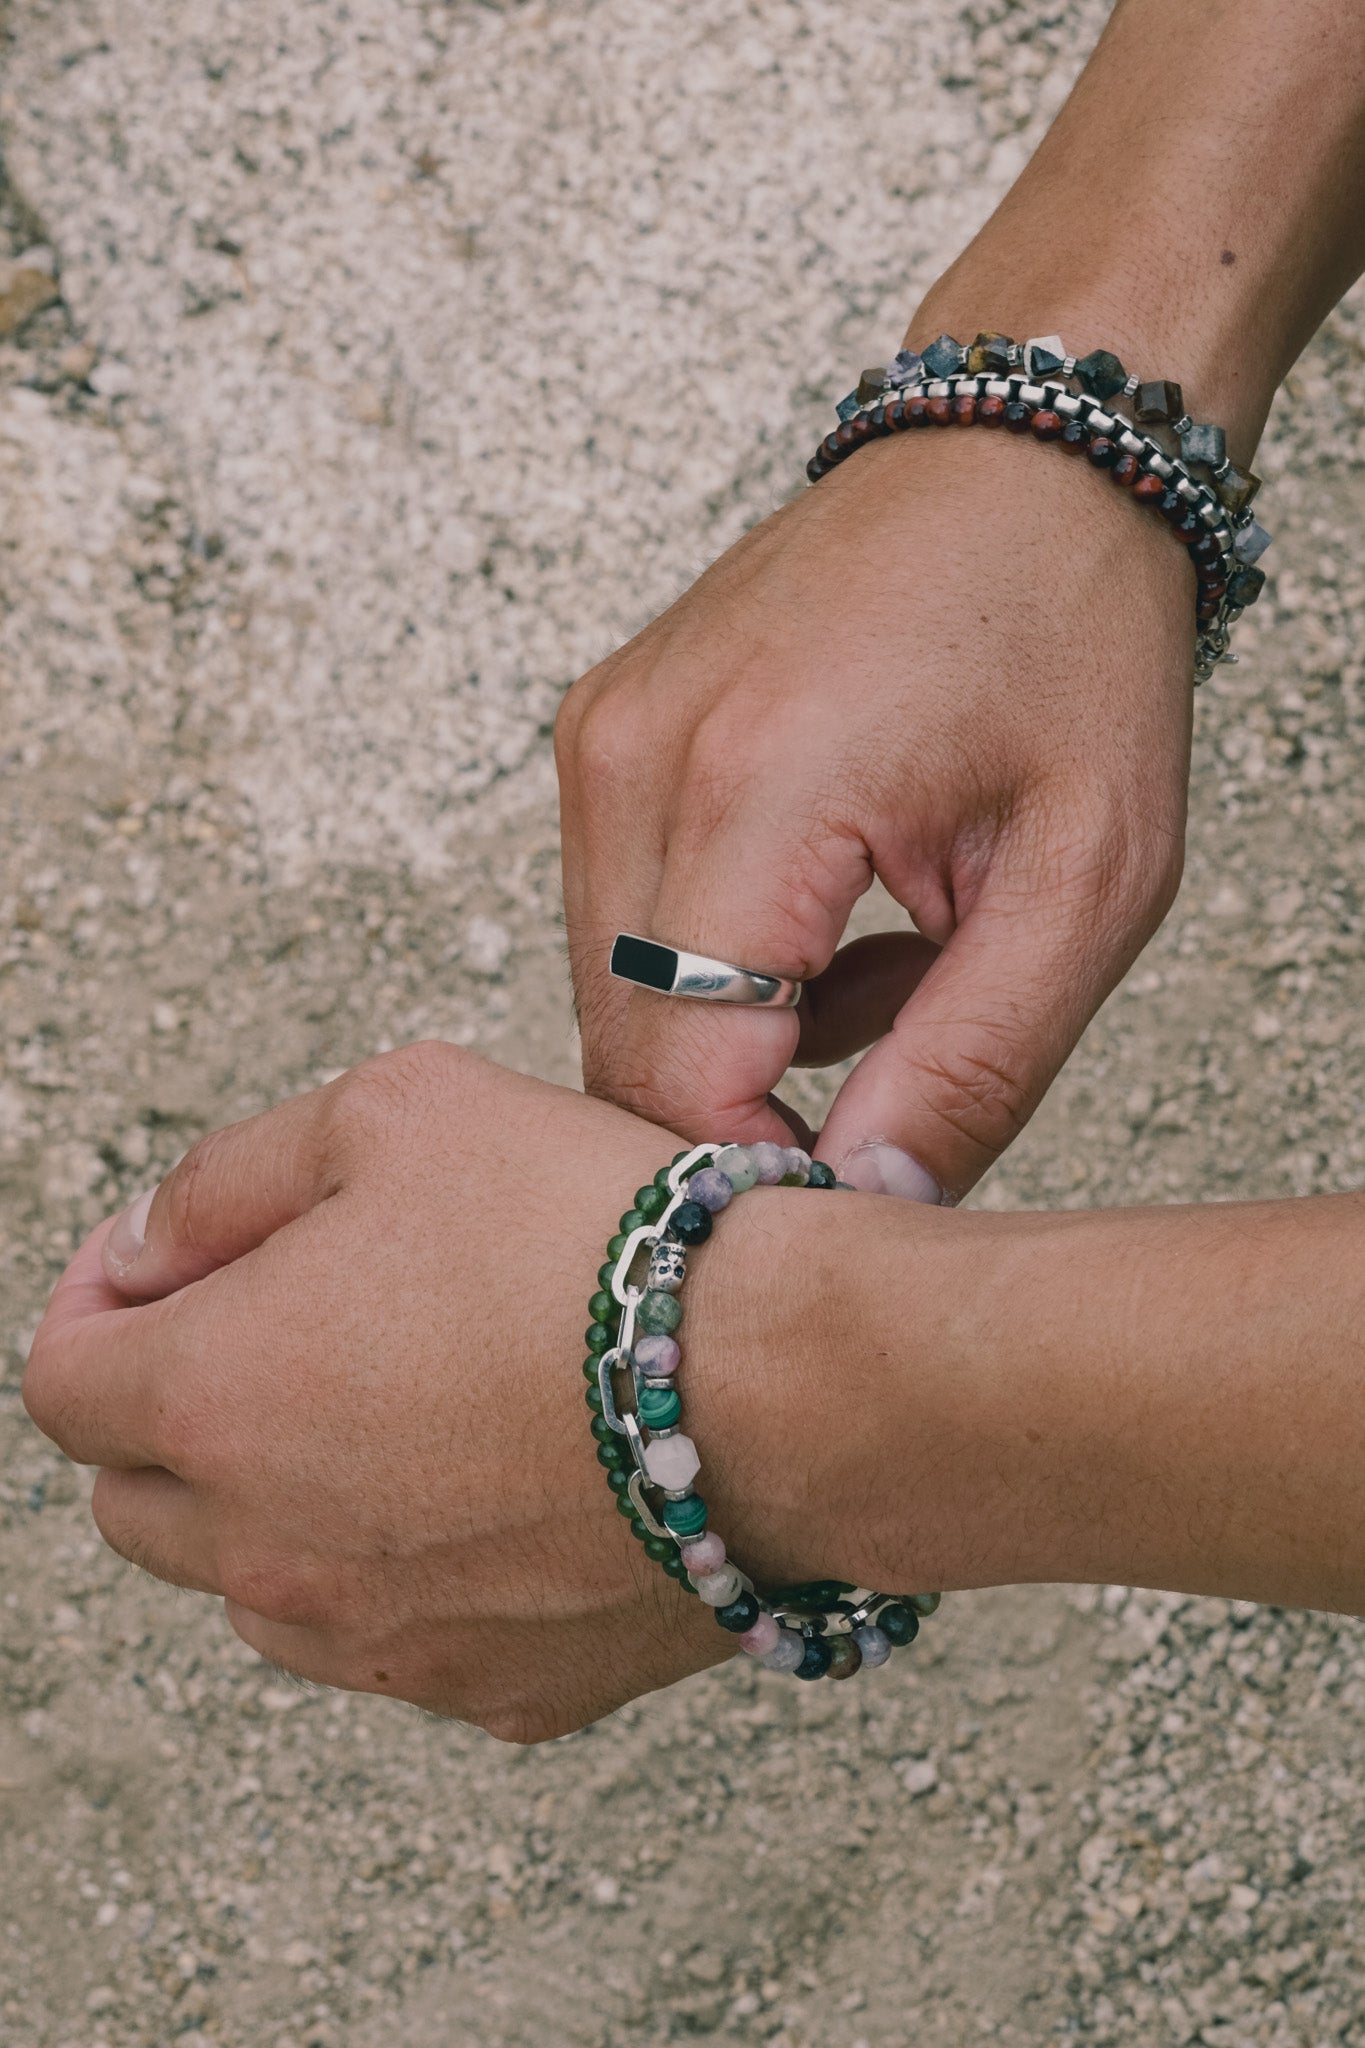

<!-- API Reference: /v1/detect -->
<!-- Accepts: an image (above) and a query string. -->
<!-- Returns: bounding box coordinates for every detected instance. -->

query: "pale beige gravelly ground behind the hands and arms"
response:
[0,0,1365,2048]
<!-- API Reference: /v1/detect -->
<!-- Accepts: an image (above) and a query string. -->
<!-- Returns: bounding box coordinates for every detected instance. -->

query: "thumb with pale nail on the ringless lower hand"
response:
[102,1087,334,1300]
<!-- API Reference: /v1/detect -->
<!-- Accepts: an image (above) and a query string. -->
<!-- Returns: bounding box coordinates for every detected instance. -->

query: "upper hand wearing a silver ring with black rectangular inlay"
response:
[557,428,1193,1200]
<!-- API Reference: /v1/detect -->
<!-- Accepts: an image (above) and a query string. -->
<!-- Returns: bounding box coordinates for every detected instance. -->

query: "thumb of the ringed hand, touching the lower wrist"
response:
[821,891,1138,1204]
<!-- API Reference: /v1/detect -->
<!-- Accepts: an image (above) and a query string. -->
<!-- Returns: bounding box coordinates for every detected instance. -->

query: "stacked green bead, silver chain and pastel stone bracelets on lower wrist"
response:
[583,1145,939,1679]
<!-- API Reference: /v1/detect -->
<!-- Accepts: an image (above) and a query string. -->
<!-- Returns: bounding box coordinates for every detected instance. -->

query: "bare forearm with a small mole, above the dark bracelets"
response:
[911,0,1365,459]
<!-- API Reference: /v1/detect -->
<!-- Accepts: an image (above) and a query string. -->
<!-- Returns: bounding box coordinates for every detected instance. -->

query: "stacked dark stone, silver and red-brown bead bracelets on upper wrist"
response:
[806,334,1271,684]
